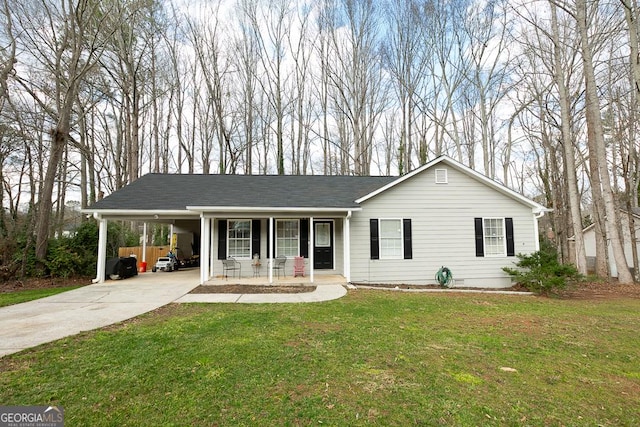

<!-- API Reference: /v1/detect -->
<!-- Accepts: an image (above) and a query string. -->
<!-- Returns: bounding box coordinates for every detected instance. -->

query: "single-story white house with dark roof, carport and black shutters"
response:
[85,156,548,287]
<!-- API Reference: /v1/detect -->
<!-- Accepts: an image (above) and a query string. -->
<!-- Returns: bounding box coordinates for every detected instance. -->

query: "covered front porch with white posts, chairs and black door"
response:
[195,207,351,284]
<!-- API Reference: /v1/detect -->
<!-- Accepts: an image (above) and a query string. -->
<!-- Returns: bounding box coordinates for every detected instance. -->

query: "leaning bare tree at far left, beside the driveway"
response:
[15,0,109,268]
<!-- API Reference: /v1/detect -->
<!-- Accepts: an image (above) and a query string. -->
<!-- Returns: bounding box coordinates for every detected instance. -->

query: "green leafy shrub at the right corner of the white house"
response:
[502,242,582,295]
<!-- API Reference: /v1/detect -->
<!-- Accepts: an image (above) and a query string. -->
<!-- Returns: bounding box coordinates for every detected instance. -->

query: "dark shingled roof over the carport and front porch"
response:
[88,174,396,211]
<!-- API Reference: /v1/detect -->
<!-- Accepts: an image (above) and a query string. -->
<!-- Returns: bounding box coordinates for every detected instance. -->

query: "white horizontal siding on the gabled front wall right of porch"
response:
[350,167,537,287]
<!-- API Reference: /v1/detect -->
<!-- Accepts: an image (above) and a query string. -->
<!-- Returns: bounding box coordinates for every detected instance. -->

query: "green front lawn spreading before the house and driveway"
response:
[0,290,640,426]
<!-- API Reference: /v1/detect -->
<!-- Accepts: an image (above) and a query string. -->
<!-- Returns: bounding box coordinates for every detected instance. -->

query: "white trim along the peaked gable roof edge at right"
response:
[356,155,550,212]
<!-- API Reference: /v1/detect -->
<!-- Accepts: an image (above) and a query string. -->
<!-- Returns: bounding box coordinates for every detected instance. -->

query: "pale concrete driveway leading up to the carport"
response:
[0,268,200,357]
